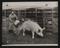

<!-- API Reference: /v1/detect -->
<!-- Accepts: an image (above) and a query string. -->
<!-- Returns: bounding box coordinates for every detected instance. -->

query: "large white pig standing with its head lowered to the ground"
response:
[19,20,45,39]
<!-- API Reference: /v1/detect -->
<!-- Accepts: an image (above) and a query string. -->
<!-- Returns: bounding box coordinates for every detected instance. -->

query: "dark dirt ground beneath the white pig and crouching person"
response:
[2,19,58,44]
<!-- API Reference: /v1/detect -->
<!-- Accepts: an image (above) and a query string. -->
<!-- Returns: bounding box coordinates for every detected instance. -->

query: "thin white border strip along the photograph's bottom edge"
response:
[2,44,58,46]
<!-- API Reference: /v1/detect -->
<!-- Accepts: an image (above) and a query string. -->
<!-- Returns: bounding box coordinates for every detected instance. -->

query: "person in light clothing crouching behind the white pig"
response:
[9,12,18,31]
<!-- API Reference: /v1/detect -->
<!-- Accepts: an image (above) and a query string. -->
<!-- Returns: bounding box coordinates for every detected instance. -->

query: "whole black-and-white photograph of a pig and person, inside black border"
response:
[2,1,58,46]
